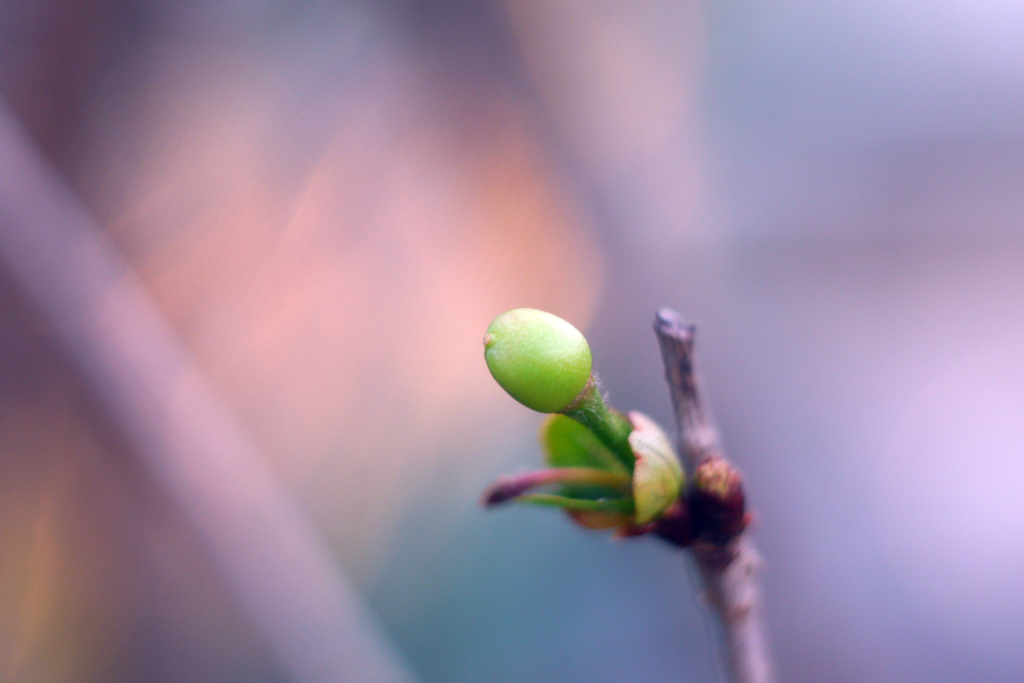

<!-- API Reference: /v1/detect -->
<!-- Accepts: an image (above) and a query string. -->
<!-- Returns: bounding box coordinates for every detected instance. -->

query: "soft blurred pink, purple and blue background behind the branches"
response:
[0,0,1024,683]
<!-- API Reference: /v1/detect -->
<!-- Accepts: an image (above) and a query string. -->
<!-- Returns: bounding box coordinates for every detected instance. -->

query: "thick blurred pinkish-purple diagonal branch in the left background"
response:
[0,101,415,683]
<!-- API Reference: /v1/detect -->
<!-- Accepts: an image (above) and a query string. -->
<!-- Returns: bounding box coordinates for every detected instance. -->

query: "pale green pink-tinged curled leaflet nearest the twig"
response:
[628,411,685,524]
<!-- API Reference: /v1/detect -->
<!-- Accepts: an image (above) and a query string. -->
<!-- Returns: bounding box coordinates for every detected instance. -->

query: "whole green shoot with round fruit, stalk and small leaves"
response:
[483,308,685,535]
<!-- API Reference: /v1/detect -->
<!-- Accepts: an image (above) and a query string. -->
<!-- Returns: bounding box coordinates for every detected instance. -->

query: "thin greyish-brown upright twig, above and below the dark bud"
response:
[654,308,775,683]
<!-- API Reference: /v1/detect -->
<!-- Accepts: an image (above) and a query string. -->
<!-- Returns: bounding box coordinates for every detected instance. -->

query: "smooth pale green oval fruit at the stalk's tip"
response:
[483,308,591,413]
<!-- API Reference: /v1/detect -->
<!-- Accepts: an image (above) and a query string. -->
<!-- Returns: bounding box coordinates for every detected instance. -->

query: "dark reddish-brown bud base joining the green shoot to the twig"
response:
[652,457,750,548]
